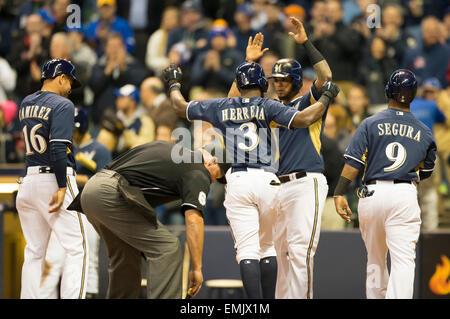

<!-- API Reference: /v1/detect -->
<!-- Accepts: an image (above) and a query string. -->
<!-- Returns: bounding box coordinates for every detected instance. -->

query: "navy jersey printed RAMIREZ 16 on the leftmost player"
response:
[19,91,75,169]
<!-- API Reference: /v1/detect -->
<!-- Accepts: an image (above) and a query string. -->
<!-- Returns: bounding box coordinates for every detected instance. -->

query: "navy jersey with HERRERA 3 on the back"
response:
[187,96,297,172]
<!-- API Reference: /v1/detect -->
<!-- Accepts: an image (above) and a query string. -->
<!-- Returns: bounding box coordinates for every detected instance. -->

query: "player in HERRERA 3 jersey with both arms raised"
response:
[163,62,338,298]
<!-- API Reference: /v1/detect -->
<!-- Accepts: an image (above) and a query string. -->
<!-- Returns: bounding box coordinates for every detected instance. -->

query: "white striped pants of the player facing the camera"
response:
[274,173,328,299]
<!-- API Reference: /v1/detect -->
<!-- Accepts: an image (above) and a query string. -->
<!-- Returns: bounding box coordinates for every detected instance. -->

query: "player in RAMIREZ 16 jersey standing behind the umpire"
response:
[16,59,89,298]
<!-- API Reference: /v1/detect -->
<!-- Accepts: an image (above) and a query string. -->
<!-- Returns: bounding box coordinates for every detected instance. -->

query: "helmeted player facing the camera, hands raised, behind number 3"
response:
[228,17,331,299]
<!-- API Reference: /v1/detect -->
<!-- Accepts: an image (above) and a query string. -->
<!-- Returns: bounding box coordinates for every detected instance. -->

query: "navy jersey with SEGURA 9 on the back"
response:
[344,109,436,182]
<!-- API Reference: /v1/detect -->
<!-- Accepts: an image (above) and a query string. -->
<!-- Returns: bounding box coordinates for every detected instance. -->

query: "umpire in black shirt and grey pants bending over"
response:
[71,142,225,299]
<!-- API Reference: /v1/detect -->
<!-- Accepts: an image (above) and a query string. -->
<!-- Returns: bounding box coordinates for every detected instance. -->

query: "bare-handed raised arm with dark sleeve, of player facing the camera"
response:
[289,17,332,92]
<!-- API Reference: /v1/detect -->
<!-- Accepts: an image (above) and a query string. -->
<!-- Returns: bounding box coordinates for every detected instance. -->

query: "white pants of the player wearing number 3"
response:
[224,168,280,263]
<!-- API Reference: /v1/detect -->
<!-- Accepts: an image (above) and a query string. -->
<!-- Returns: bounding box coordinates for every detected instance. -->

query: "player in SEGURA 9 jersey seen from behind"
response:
[334,69,436,299]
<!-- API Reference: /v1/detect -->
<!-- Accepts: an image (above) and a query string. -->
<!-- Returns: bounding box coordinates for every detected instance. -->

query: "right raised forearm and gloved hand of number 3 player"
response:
[291,82,339,128]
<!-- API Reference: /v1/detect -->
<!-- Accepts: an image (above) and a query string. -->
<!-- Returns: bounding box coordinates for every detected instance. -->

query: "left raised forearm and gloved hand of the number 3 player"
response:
[162,64,188,118]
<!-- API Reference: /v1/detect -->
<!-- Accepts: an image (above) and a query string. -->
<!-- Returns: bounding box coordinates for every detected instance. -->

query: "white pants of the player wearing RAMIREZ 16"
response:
[16,167,88,299]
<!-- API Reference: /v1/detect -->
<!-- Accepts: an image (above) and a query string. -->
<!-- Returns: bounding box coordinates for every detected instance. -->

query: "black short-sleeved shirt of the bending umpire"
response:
[68,141,211,221]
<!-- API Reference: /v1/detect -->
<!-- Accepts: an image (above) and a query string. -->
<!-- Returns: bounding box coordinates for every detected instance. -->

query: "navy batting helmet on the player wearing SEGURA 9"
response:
[385,69,417,104]
